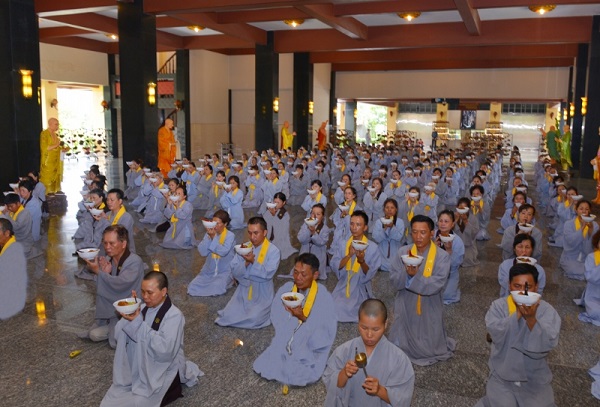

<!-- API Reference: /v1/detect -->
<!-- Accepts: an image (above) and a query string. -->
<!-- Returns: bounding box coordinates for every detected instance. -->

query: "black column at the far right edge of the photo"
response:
[579,16,600,178]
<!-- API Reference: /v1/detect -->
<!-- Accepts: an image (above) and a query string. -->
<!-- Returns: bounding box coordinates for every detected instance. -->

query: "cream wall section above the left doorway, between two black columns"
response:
[40,43,108,85]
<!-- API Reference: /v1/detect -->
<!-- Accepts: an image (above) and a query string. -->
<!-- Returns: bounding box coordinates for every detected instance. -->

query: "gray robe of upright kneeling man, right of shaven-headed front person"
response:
[389,245,456,366]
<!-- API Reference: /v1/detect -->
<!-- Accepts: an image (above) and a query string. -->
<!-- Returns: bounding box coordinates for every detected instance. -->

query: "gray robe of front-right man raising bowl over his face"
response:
[477,297,561,407]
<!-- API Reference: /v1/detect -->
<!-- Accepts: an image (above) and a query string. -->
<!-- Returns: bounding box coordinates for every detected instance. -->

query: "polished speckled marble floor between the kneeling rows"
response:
[0,156,600,407]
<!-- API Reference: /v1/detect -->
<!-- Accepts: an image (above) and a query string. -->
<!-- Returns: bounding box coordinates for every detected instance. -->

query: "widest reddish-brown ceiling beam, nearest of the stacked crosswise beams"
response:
[275,17,592,53]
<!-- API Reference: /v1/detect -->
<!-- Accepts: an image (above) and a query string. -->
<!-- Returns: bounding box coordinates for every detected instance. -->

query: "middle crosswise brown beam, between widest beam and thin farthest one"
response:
[310,44,578,64]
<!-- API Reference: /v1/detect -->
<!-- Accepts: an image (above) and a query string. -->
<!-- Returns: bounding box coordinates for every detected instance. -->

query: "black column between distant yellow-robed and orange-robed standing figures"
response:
[293,52,313,149]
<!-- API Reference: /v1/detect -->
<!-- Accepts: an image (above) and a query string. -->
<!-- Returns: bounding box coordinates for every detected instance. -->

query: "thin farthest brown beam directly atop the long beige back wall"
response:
[331,58,575,72]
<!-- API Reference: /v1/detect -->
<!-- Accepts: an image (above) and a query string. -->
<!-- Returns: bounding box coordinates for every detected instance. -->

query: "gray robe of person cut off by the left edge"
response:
[0,242,27,320]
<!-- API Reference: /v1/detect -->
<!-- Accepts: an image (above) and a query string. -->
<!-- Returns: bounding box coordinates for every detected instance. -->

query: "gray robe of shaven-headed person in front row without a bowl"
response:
[323,336,415,407]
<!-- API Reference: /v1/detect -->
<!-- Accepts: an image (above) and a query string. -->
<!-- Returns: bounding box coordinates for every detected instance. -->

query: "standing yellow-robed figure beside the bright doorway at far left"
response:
[40,118,61,194]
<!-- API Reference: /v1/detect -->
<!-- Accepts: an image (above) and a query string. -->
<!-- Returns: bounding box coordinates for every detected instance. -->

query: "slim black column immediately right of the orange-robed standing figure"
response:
[175,49,192,158]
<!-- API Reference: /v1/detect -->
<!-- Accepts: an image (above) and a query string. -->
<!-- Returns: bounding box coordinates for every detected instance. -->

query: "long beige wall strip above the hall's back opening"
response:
[336,68,569,101]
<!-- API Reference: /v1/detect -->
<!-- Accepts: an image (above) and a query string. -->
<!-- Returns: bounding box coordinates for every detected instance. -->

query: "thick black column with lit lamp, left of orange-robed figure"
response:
[118,0,159,167]
